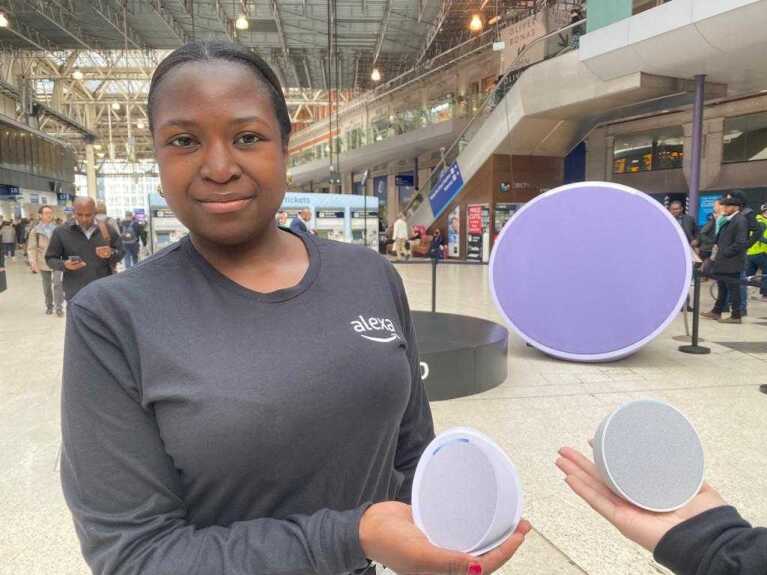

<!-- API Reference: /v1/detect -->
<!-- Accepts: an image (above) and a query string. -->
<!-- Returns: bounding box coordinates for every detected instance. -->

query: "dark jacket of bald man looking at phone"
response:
[45,223,125,301]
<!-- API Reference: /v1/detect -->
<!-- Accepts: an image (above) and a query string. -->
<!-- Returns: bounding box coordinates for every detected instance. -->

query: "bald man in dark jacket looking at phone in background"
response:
[45,197,124,302]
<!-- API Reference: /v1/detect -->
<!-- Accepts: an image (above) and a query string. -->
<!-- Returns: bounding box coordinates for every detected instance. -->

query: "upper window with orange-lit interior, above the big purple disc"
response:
[613,127,684,174]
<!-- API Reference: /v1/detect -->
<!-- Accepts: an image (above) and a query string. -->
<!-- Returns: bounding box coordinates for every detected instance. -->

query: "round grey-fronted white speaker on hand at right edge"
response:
[593,399,703,512]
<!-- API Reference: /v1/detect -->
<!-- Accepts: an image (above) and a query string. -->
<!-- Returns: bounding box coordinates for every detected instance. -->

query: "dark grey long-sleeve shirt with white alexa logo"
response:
[61,234,434,575]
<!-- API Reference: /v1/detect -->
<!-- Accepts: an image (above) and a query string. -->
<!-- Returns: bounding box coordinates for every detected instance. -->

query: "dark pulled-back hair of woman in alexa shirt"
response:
[147,40,291,145]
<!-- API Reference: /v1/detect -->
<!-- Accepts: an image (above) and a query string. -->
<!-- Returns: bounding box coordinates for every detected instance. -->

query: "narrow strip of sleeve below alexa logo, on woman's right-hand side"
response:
[386,262,434,504]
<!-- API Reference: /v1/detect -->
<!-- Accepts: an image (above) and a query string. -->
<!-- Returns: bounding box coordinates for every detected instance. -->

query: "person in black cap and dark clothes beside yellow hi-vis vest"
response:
[701,195,748,323]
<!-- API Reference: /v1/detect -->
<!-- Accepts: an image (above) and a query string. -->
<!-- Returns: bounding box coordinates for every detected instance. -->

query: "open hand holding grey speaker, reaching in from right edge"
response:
[557,447,727,552]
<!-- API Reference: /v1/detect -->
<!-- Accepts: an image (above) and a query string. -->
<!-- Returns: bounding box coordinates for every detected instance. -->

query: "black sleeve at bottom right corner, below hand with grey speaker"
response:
[654,506,767,575]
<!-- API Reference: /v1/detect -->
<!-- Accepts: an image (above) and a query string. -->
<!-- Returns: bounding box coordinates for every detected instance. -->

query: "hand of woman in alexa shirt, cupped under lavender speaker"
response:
[359,501,530,575]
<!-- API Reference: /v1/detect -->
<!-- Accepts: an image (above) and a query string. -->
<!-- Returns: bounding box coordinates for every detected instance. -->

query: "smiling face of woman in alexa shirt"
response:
[152,60,287,245]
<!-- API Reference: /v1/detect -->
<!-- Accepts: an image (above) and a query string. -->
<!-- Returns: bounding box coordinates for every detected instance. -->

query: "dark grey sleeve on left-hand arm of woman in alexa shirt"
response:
[61,301,368,575]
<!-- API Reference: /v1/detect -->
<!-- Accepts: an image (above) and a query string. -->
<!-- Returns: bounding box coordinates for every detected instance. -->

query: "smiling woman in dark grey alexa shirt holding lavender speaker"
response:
[62,43,529,575]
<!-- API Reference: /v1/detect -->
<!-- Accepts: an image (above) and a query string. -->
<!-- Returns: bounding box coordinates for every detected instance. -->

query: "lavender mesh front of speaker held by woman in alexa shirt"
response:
[419,440,497,551]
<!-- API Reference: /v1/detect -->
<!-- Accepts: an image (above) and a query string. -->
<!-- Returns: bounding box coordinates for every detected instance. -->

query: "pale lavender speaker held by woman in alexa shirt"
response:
[412,427,523,555]
